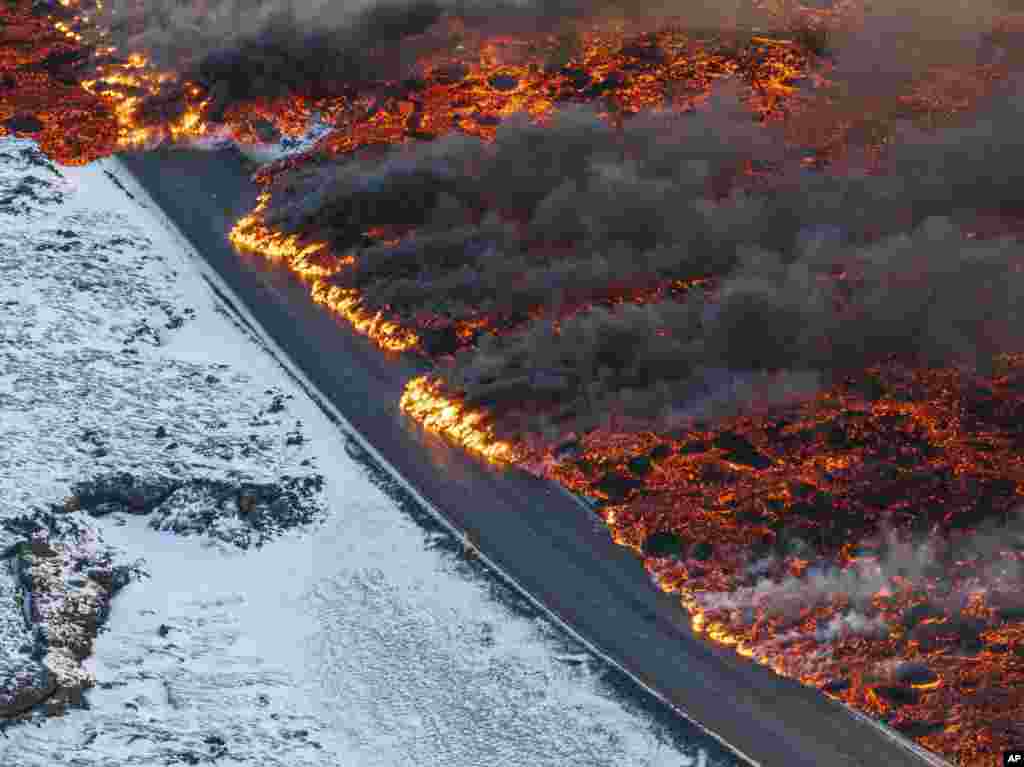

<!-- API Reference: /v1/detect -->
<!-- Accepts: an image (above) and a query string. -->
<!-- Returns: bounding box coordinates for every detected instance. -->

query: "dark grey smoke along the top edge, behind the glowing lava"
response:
[97,0,618,120]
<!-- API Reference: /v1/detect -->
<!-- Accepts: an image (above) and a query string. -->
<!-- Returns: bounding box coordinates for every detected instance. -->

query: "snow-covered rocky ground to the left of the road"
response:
[0,139,733,767]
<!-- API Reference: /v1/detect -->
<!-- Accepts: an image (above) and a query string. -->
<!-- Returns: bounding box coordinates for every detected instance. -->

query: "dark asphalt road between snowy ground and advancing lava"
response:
[121,151,946,767]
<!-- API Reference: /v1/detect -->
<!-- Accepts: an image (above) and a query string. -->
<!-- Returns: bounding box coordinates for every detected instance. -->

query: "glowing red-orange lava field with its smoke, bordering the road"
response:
[0,0,1024,767]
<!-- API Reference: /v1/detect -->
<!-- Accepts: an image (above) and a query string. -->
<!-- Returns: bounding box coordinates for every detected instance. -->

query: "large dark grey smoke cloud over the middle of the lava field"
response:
[258,71,1024,428]
